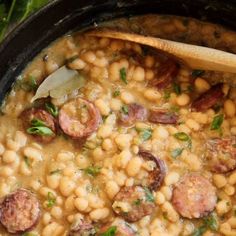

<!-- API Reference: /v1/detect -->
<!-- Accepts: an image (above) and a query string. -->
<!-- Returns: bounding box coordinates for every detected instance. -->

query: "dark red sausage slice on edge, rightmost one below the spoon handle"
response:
[192,83,224,111]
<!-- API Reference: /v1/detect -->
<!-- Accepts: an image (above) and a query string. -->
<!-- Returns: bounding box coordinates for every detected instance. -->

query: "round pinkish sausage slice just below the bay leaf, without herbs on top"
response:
[59,98,101,139]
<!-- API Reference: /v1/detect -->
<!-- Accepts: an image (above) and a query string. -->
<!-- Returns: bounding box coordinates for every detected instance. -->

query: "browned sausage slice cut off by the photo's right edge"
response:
[206,136,236,173]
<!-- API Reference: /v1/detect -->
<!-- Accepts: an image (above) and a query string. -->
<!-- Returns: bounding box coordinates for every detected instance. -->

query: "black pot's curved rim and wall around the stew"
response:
[0,0,236,101]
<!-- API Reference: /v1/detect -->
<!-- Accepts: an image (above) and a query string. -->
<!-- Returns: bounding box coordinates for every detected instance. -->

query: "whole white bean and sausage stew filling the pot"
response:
[0,15,236,236]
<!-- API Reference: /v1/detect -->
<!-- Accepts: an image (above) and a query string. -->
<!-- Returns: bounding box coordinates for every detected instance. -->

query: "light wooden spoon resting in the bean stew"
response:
[87,28,236,73]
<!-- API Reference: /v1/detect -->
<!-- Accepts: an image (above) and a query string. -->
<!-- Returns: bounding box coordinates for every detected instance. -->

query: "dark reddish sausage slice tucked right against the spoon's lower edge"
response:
[149,59,179,89]
